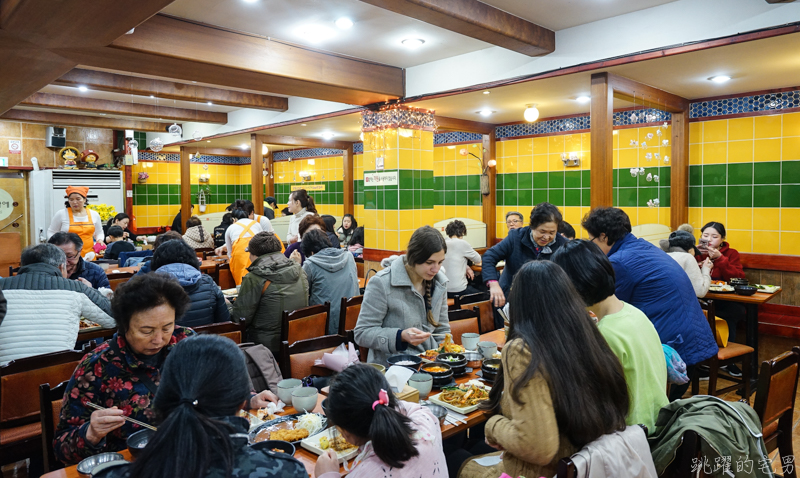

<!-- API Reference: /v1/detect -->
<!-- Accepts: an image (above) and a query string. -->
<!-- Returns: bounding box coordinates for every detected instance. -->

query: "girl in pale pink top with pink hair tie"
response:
[314,365,448,478]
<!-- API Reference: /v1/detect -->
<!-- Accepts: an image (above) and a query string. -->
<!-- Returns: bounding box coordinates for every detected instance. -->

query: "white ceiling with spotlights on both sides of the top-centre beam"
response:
[161,0,675,68]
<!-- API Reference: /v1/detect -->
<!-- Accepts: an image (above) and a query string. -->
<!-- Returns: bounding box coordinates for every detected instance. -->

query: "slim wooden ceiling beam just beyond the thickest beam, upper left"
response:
[53,68,289,111]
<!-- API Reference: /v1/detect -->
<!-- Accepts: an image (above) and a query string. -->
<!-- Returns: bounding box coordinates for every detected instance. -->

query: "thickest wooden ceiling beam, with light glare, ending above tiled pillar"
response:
[54,15,405,105]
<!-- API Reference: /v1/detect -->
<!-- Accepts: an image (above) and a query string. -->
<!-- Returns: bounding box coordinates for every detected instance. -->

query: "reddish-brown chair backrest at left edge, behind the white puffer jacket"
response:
[0,350,86,428]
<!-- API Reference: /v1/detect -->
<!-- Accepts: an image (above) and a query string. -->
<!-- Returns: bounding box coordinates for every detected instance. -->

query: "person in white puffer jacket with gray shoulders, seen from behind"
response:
[0,244,117,365]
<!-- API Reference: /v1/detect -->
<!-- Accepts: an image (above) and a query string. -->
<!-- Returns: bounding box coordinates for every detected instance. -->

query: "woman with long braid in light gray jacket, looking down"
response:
[354,226,450,364]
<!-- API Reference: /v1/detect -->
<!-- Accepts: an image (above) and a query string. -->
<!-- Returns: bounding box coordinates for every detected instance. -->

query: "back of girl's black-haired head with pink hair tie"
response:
[325,365,419,468]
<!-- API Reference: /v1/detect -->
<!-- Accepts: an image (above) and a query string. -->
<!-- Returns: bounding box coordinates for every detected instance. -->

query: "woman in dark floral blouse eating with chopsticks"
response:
[53,273,277,464]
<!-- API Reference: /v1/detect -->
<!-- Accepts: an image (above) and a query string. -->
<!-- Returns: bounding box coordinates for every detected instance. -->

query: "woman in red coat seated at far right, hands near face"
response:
[695,222,747,377]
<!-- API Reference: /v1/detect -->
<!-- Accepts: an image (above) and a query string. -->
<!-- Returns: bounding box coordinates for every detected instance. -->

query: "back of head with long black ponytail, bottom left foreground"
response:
[130,335,250,478]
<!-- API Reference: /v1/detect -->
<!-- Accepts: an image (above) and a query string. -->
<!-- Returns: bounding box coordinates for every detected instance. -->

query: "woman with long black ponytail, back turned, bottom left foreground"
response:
[95,335,308,478]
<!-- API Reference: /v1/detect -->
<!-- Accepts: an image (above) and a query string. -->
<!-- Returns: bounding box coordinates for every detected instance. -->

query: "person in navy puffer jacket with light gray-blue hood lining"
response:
[151,241,231,327]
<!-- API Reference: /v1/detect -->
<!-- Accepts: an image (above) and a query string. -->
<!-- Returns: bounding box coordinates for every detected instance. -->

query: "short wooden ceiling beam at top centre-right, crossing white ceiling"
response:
[361,0,556,56]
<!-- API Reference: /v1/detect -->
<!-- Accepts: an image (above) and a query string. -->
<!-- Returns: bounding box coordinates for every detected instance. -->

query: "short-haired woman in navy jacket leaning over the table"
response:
[482,202,567,307]
